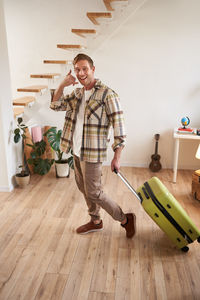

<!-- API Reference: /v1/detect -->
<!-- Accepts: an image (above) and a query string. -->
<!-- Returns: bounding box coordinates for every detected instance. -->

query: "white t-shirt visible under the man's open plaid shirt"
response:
[73,90,92,157]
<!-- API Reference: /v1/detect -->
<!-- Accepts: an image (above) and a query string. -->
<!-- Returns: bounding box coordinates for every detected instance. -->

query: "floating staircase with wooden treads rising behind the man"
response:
[13,0,133,117]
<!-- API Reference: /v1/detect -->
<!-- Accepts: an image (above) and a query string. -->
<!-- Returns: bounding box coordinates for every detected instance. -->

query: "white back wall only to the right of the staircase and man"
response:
[95,0,200,168]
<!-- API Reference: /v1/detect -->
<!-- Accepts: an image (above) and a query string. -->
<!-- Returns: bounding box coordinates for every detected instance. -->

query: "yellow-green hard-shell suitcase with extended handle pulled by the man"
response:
[115,171,200,252]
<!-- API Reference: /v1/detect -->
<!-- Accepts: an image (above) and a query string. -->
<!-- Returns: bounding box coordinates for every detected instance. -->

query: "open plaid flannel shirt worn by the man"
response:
[50,80,126,162]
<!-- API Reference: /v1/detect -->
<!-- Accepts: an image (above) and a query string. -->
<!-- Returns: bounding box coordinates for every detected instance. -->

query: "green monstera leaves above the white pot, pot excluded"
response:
[44,127,74,169]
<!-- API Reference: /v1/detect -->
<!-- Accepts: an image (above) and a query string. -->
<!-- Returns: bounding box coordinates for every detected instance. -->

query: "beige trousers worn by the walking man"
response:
[74,155,125,222]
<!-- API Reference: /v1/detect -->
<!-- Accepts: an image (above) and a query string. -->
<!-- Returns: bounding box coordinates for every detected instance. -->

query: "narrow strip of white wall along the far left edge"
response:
[0,0,15,192]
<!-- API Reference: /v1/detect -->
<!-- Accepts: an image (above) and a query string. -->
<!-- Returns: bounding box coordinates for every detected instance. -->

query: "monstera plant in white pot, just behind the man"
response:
[44,127,74,177]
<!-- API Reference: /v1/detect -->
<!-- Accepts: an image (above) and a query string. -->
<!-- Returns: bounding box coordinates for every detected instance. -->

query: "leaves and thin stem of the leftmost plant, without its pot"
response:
[14,118,29,177]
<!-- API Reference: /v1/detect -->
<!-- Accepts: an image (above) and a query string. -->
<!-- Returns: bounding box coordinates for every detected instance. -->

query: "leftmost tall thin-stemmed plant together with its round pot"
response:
[14,118,30,187]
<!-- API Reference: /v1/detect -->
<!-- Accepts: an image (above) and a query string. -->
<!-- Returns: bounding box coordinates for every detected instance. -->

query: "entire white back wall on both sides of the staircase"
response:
[5,0,200,169]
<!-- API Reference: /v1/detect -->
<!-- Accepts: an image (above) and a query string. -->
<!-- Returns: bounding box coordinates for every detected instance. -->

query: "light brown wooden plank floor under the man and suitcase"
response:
[0,167,200,300]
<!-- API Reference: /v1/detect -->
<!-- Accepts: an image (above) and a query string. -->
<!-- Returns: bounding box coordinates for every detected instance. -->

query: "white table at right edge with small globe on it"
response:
[173,129,200,183]
